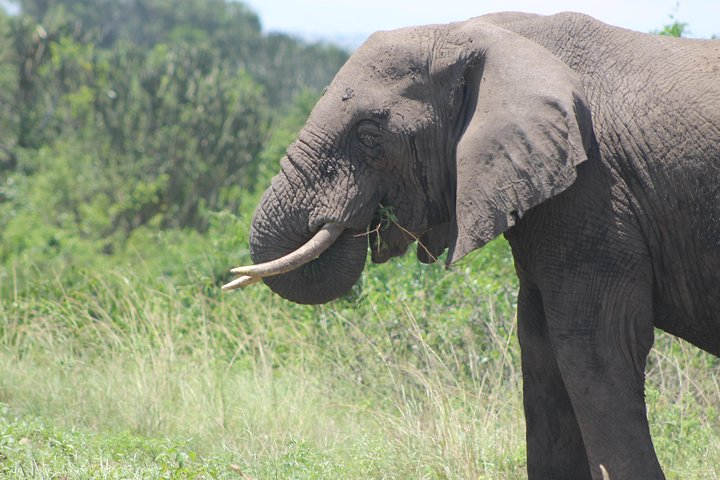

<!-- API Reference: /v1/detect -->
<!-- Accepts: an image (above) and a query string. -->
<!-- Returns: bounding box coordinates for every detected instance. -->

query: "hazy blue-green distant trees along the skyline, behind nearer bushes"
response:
[19,0,348,107]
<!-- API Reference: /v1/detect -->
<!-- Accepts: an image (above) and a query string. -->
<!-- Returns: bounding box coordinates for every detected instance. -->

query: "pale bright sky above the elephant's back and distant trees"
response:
[245,0,720,46]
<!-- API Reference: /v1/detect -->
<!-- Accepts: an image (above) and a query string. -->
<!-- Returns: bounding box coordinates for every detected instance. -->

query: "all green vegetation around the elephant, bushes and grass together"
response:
[0,0,720,480]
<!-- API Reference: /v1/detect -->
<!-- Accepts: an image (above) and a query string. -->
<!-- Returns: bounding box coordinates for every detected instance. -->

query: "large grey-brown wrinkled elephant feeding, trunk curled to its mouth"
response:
[223,12,720,480]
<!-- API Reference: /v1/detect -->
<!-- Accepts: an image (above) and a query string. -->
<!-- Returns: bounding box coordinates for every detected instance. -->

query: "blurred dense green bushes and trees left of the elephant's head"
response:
[0,0,347,292]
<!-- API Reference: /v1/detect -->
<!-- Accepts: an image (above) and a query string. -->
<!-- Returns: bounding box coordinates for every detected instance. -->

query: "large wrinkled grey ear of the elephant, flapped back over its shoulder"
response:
[446,20,595,264]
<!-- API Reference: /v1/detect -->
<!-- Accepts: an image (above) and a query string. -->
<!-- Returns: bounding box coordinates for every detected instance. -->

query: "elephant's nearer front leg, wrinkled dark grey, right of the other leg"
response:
[543,276,665,480]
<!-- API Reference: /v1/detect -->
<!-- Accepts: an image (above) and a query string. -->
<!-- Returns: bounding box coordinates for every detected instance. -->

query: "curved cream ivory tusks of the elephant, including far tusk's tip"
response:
[222,223,345,284]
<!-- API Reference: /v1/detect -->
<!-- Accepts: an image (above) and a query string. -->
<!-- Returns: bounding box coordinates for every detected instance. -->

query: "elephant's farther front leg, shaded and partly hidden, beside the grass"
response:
[518,286,591,480]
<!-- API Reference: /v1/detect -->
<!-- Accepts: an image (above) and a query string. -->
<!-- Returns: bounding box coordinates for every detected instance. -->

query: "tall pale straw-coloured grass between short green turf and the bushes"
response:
[0,238,523,478]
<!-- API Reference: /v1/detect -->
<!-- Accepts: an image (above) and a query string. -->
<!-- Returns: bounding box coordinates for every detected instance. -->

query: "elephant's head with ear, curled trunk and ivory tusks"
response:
[224,19,593,303]
